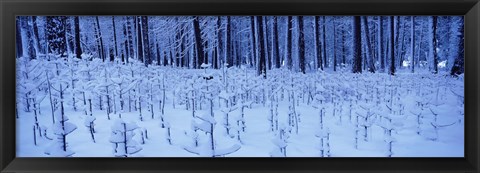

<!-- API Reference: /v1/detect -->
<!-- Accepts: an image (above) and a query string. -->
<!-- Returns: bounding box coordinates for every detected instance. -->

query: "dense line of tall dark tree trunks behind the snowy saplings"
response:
[16,16,464,77]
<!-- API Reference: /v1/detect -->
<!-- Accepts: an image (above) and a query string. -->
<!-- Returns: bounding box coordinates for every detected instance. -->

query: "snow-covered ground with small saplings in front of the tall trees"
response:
[16,60,464,157]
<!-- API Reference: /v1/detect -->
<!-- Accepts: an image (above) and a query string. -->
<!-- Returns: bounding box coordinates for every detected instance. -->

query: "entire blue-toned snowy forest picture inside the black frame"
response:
[15,16,464,157]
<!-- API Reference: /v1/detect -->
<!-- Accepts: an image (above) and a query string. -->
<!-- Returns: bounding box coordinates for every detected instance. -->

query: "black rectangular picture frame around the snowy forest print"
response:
[0,0,480,173]
